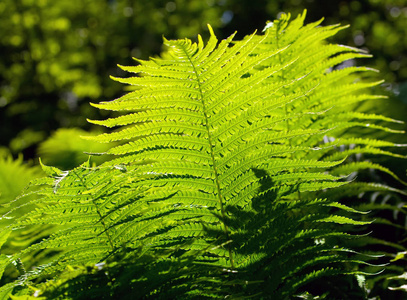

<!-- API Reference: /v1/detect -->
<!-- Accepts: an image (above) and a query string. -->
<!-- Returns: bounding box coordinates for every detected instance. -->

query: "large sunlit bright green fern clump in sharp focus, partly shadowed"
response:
[0,13,406,299]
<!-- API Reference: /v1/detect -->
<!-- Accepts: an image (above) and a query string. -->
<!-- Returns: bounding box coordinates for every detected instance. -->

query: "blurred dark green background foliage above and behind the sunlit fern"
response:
[0,0,407,162]
